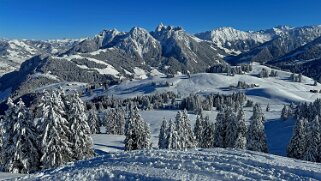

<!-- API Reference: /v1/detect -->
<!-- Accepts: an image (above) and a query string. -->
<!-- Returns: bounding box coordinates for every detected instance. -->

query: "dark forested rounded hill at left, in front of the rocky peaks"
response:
[0,55,116,97]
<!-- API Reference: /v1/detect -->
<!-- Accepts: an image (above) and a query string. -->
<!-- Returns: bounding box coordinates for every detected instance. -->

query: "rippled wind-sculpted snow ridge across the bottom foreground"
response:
[20,148,321,181]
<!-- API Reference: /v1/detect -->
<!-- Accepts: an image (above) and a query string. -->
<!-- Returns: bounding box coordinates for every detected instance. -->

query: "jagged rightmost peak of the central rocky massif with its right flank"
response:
[152,24,226,72]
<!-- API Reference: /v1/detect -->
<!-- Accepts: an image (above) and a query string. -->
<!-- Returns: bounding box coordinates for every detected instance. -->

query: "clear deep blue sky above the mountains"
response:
[0,0,321,39]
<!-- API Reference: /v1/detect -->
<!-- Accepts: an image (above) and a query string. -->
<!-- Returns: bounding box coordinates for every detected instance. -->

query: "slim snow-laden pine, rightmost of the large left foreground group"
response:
[67,92,94,160]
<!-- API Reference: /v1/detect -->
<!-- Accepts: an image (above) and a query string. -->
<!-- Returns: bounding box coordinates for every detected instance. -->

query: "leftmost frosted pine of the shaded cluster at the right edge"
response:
[287,119,308,159]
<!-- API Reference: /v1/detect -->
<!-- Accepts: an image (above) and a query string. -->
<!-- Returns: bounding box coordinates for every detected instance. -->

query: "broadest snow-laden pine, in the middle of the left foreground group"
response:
[39,91,74,168]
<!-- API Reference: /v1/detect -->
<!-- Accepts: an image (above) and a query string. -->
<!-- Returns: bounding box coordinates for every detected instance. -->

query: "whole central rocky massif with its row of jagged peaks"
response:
[62,25,226,73]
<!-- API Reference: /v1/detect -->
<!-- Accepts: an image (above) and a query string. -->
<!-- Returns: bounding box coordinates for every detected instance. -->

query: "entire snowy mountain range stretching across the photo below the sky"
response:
[0,24,321,99]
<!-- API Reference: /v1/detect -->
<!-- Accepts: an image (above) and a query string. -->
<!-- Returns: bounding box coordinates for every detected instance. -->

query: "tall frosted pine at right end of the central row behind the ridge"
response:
[246,104,268,153]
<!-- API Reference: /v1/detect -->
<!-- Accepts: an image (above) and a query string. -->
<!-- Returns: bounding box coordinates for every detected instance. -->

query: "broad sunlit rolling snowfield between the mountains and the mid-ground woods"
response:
[108,64,321,104]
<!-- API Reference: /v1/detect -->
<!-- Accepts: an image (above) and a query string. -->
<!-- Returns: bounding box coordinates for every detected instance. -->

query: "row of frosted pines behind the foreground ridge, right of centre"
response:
[158,104,268,152]
